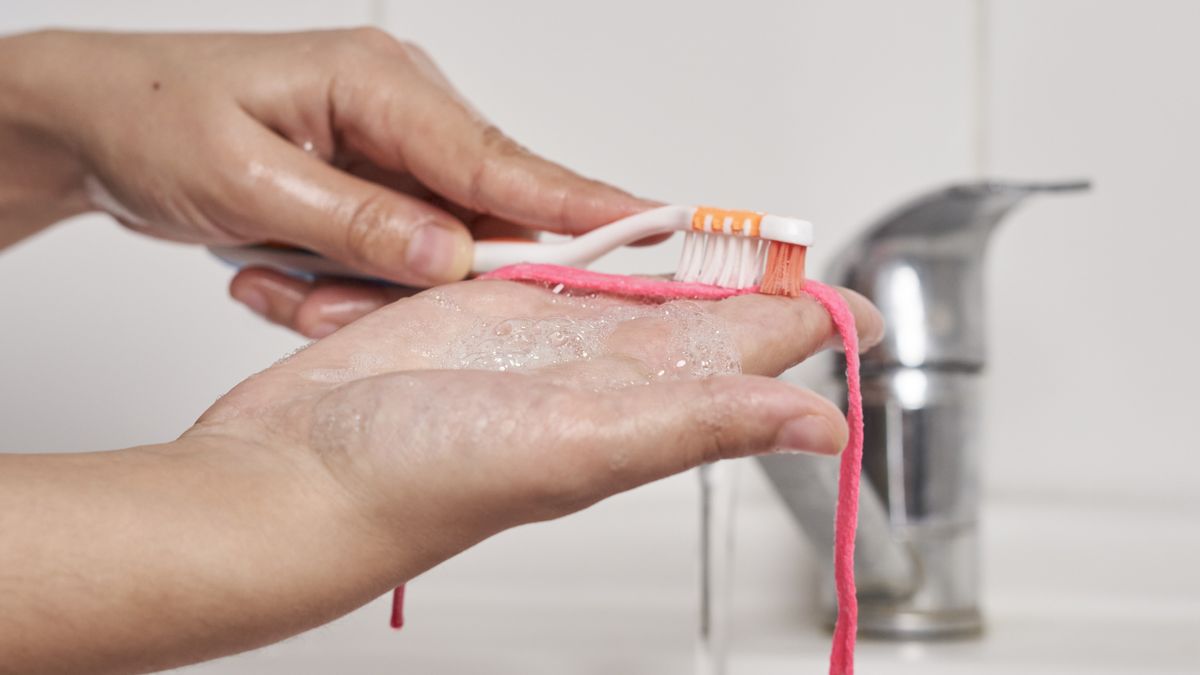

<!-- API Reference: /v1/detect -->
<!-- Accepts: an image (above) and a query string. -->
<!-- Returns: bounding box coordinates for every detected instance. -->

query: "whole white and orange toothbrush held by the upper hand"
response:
[210,205,812,295]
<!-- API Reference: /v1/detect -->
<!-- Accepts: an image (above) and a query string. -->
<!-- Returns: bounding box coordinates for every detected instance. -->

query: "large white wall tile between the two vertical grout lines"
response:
[385,0,973,271]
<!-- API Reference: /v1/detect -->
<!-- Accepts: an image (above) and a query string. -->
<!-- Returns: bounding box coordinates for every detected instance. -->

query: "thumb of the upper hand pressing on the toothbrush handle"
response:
[218,121,473,286]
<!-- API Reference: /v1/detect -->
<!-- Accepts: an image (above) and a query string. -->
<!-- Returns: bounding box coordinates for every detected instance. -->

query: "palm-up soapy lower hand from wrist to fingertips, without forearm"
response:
[191,281,882,585]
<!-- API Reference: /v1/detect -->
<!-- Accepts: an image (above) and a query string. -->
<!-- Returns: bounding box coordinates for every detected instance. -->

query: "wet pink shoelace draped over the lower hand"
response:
[391,264,863,675]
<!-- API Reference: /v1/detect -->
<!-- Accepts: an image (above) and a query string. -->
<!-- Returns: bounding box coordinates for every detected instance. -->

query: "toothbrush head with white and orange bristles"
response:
[674,201,812,295]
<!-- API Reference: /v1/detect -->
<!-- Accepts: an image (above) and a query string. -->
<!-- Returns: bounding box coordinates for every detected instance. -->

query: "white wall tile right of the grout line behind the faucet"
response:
[986,0,1200,499]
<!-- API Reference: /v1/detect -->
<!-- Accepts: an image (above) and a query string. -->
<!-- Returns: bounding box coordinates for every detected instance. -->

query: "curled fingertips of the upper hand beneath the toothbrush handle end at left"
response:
[229,268,415,340]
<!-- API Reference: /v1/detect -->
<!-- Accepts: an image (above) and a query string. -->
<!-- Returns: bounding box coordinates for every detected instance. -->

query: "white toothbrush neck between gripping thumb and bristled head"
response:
[470,201,695,274]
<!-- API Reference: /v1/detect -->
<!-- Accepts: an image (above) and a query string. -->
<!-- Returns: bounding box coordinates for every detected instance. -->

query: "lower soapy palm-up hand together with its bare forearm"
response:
[0,276,881,674]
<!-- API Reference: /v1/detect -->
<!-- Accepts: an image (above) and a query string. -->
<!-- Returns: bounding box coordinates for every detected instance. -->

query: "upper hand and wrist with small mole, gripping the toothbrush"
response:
[0,29,653,270]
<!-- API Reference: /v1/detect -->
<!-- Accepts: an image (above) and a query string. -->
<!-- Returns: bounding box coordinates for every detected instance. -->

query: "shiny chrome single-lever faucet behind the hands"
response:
[760,181,1088,639]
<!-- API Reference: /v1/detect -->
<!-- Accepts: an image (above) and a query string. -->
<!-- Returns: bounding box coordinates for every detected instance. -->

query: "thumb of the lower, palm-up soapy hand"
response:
[558,376,848,498]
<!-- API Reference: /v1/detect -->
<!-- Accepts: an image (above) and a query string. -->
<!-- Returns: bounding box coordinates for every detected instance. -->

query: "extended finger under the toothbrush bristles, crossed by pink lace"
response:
[709,288,883,376]
